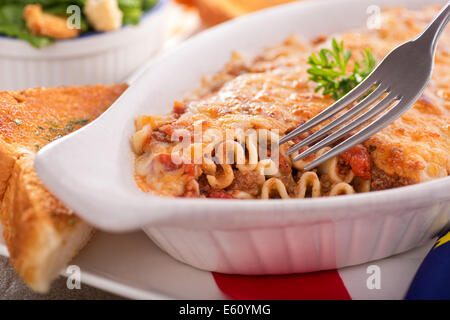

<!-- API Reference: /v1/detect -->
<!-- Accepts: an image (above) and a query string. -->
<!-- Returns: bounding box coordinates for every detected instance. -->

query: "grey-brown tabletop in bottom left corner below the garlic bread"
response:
[0,256,122,300]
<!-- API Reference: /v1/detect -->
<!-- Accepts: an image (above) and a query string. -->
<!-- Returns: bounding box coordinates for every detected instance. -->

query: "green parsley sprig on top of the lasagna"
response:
[307,38,376,100]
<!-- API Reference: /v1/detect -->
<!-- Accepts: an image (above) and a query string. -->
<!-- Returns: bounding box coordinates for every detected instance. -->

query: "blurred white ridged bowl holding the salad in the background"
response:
[0,0,167,91]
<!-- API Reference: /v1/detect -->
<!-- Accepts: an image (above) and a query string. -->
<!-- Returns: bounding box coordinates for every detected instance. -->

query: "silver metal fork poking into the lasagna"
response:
[279,2,450,170]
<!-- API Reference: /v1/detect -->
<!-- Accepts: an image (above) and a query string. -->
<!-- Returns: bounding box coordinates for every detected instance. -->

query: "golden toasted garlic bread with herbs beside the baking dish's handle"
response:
[0,85,126,292]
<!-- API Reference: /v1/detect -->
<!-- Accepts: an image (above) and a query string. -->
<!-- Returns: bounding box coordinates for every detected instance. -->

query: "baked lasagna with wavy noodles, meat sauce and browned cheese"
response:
[131,7,450,199]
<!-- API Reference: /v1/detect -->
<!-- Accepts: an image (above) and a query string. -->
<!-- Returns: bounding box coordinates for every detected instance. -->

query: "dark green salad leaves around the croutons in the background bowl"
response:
[0,0,158,48]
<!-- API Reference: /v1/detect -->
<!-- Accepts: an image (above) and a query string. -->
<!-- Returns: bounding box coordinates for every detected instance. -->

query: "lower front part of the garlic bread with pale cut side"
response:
[0,155,93,292]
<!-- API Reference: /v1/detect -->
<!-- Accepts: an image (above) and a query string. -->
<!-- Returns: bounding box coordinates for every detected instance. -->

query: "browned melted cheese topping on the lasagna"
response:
[132,7,450,196]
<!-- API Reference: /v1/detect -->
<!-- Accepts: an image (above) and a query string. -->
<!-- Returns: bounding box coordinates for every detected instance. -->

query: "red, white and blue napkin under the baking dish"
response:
[213,233,450,300]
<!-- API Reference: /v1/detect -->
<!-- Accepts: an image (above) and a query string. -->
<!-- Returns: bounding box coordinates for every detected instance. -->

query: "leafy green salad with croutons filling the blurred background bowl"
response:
[0,0,162,48]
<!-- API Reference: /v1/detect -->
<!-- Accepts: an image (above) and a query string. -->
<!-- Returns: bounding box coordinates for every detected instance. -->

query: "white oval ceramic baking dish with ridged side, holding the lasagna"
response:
[35,0,450,274]
